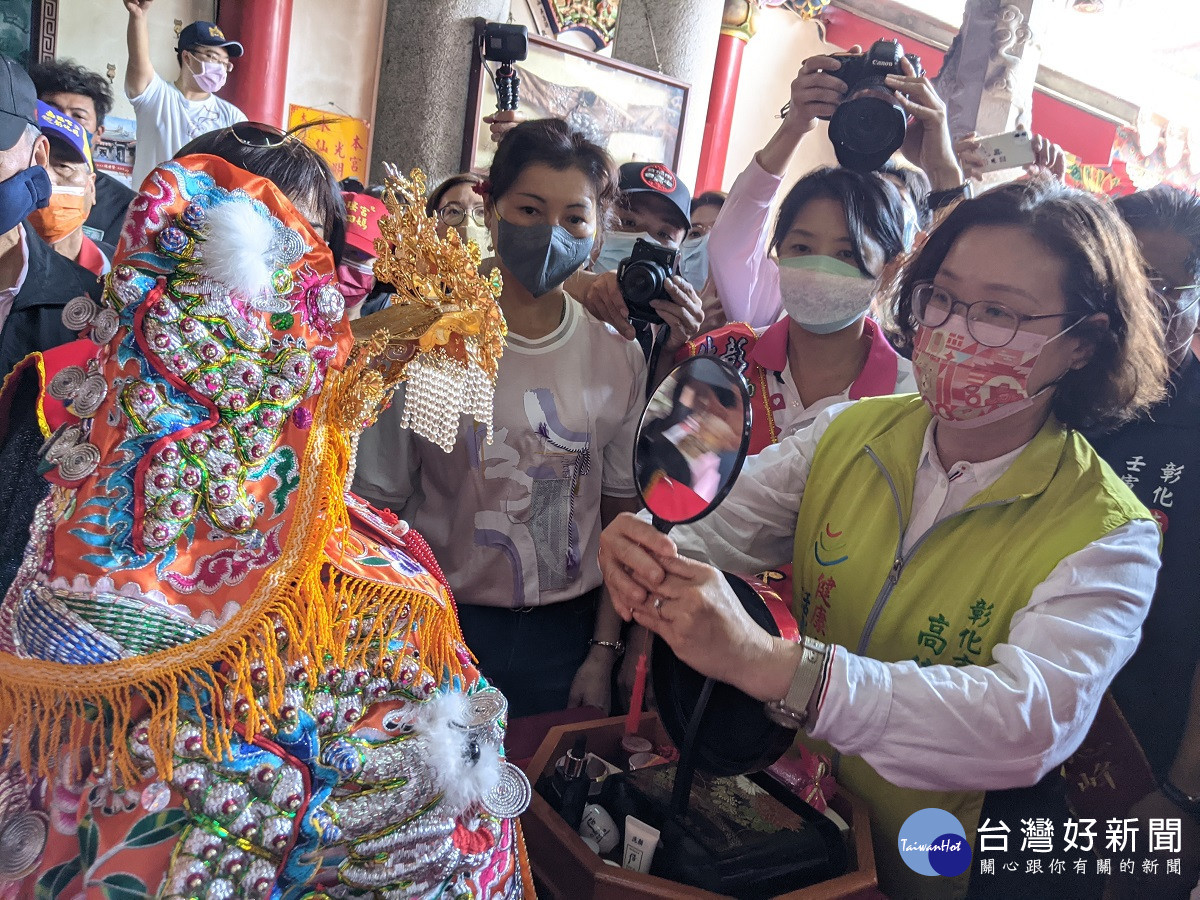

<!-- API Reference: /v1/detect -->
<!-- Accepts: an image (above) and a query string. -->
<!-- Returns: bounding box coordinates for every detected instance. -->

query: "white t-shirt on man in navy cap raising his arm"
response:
[130,74,246,190]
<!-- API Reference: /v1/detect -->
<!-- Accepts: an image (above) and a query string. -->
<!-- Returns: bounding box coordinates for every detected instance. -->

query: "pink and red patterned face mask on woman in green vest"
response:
[912,313,1078,428]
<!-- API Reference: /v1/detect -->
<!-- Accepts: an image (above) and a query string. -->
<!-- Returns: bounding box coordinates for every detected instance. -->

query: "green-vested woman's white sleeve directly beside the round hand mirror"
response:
[667,403,851,575]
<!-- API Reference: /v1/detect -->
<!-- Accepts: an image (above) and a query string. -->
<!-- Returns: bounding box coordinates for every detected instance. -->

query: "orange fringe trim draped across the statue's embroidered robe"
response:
[0,354,463,785]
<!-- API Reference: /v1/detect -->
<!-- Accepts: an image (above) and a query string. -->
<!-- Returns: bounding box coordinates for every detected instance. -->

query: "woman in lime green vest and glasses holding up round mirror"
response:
[600,180,1166,898]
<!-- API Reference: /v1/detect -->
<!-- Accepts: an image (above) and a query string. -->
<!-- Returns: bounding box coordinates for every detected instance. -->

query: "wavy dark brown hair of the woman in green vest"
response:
[884,178,1168,428]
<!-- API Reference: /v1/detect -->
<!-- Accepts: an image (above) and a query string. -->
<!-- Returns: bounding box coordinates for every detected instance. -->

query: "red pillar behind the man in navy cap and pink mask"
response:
[217,0,292,127]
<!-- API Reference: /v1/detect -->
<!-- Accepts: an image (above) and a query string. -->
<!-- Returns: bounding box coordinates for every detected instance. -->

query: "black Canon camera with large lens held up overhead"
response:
[829,41,925,172]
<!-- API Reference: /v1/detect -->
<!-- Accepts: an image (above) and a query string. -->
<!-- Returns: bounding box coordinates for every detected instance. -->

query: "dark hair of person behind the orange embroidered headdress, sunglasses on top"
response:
[175,122,346,265]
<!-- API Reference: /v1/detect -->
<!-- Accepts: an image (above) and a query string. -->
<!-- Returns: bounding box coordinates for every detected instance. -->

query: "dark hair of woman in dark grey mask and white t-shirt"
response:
[487,119,617,226]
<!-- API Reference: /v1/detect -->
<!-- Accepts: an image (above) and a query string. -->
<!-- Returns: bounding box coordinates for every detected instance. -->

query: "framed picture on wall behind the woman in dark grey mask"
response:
[462,35,689,173]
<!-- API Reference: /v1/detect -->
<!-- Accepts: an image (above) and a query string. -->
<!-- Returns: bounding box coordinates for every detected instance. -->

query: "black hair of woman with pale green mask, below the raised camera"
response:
[770,166,905,275]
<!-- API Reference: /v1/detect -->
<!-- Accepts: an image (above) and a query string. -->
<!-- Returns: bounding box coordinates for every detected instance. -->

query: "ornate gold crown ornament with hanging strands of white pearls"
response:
[350,168,508,451]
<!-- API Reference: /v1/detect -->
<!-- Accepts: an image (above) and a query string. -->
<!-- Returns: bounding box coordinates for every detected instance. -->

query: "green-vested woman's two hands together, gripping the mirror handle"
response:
[600,515,799,700]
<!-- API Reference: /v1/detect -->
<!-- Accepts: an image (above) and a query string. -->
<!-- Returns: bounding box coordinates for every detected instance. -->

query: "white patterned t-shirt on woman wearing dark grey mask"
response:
[354,298,646,607]
